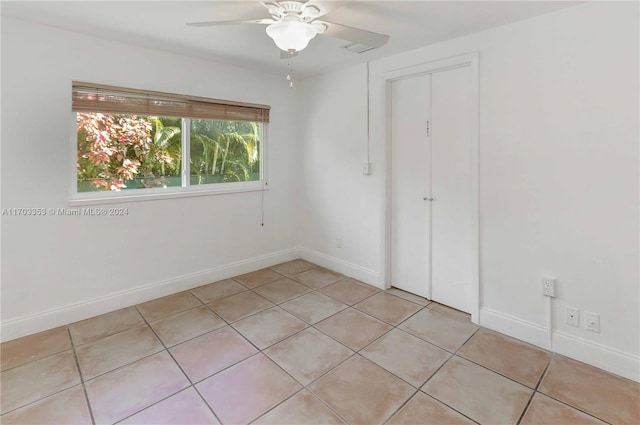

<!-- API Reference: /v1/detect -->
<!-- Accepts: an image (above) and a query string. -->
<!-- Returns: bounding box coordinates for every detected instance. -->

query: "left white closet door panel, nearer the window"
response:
[390,75,431,298]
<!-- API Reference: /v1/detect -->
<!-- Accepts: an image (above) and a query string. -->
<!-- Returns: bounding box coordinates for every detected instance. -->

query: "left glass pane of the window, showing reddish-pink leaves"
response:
[77,112,182,193]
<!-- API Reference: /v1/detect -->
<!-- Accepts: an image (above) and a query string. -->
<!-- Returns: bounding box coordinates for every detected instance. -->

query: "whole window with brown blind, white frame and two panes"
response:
[73,82,269,200]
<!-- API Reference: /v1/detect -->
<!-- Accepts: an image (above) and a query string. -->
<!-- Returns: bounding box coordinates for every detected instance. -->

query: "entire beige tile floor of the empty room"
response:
[0,260,640,425]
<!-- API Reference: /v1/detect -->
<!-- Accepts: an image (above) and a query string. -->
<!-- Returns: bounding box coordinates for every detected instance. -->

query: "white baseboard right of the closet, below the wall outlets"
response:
[480,308,640,382]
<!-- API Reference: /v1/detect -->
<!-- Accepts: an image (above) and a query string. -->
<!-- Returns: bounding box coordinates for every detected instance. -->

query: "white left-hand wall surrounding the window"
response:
[2,17,298,340]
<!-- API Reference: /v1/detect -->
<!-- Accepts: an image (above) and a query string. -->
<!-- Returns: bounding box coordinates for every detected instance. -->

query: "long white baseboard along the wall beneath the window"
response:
[0,248,300,342]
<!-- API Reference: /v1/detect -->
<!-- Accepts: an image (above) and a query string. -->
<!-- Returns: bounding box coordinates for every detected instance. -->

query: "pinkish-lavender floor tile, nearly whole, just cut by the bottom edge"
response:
[196,354,302,424]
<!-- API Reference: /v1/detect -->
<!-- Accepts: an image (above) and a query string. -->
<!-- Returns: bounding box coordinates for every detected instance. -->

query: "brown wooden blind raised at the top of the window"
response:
[72,81,271,123]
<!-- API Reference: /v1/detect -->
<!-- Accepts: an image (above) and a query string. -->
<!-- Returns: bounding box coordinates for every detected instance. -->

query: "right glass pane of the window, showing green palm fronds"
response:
[190,119,262,185]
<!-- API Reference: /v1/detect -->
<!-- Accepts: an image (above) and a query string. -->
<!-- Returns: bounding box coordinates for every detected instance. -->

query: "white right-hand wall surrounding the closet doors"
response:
[300,2,640,380]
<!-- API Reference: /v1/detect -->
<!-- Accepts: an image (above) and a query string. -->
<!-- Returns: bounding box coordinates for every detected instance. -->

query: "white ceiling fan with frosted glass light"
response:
[187,0,389,55]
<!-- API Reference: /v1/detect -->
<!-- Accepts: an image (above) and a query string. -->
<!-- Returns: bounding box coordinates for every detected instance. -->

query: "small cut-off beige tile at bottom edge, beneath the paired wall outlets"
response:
[520,393,605,425]
